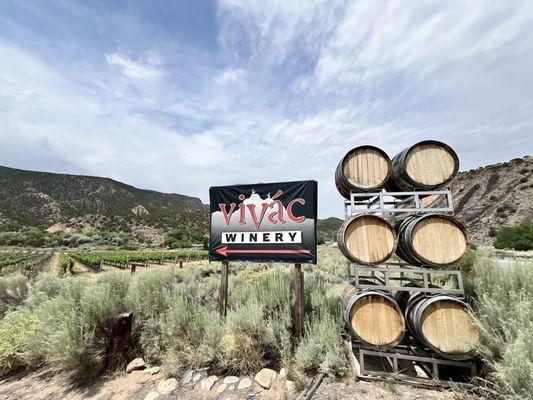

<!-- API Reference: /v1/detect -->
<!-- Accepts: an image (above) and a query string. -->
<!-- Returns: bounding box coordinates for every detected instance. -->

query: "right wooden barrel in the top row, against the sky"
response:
[385,140,459,192]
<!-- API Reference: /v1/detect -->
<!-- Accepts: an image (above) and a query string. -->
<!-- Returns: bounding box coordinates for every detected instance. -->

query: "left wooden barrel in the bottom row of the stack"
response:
[341,282,405,348]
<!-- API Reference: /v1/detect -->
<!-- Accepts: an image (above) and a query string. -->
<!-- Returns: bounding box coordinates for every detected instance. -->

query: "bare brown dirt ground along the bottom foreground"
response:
[0,371,454,400]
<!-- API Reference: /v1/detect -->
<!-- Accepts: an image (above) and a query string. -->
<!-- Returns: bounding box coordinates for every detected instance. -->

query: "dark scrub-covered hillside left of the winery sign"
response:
[0,166,207,231]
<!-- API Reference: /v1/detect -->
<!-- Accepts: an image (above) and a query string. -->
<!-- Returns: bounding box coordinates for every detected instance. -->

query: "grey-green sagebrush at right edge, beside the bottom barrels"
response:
[466,256,533,399]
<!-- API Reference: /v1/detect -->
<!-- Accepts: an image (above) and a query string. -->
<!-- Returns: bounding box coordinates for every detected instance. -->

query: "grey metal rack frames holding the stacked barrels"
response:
[344,188,476,387]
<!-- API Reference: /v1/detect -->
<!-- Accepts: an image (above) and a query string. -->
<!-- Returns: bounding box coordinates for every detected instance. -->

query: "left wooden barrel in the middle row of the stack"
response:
[337,214,398,265]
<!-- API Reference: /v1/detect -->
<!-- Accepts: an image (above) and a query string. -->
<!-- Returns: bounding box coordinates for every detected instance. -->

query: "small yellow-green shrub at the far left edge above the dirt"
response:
[0,310,36,376]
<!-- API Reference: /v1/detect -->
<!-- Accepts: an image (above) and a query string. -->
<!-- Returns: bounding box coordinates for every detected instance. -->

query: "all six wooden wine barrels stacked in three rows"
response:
[335,140,479,360]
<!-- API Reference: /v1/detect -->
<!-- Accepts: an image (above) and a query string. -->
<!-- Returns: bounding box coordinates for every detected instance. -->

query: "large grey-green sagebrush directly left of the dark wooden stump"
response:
[25,272,129,379]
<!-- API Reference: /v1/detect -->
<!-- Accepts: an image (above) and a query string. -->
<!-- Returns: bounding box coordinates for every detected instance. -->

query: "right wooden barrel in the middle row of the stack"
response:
[396,214,470,268]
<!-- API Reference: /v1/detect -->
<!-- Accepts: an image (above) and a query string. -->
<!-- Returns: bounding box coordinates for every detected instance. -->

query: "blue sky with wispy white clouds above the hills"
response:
[0,0,533,218]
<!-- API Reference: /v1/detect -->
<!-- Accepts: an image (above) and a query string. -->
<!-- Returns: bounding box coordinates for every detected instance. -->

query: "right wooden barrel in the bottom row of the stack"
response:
[405,293,479,360]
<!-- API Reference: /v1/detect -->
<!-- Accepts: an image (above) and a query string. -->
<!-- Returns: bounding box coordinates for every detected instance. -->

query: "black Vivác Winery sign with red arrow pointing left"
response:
[209,181,317,264]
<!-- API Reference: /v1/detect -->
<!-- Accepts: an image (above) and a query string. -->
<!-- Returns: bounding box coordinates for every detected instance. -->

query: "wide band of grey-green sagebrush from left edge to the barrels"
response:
[0,263,346,378]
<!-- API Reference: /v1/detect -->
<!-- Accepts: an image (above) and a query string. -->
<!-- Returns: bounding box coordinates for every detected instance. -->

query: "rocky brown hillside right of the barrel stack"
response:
[452,156,533,244]
